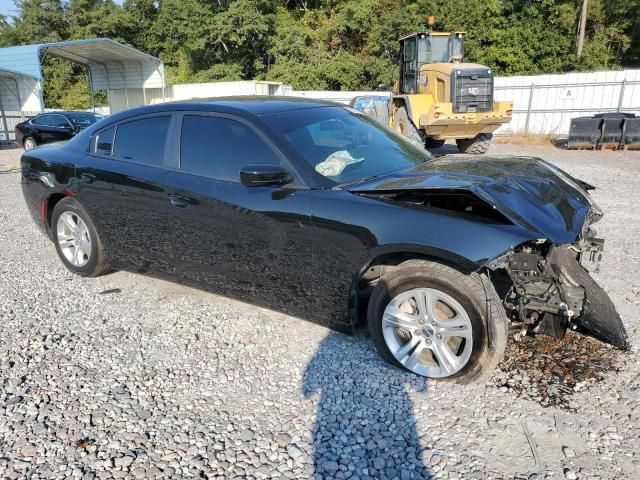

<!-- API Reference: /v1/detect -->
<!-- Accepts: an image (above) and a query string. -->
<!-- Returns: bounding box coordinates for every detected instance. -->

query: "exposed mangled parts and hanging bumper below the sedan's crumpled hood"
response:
[487,237,628,349]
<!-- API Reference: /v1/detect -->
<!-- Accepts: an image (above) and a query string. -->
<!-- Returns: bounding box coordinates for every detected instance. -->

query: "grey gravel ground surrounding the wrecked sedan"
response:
[0,145,640,480]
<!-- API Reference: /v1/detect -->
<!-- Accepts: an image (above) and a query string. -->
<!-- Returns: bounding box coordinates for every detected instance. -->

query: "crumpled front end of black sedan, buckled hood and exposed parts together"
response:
[350,155,628,349]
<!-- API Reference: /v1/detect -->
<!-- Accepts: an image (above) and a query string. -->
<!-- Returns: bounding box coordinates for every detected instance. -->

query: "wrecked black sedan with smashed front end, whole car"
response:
[22,98,627,382]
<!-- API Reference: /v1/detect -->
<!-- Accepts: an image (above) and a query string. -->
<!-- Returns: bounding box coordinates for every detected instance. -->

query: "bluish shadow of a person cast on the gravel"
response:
[302,333,433,480]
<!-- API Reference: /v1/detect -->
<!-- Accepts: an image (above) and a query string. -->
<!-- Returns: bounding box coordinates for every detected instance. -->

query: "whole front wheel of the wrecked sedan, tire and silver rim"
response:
[368,260,507,383]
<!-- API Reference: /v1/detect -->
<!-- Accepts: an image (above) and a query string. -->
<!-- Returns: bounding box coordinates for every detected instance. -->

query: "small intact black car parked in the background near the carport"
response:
[16,112,103,150]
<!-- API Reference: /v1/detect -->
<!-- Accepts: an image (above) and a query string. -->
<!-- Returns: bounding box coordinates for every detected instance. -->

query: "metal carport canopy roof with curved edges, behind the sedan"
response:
[0,38,165,108]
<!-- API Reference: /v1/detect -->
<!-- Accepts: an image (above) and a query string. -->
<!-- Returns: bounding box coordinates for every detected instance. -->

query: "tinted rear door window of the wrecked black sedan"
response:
[114,116,171,166]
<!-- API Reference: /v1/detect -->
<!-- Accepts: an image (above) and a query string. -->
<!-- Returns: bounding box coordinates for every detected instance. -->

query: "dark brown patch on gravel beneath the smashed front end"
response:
[492,331,624,411]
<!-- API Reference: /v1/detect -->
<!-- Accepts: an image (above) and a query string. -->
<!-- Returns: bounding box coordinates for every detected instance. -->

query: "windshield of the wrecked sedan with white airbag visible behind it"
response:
[269,107,431,185]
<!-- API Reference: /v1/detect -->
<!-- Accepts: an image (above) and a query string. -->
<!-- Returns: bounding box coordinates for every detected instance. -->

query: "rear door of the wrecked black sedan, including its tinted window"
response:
[76,113,174,271]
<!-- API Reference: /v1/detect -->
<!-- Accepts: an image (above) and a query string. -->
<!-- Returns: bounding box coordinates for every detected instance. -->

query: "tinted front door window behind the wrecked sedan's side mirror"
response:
[180,115,280,180]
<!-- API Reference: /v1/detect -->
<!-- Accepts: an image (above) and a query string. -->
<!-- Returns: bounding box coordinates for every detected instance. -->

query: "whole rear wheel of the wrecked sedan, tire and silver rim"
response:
[51,198,108,277]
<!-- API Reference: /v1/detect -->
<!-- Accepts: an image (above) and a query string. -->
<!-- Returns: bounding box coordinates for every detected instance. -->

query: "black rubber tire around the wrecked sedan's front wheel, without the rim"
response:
[367,260,508,384]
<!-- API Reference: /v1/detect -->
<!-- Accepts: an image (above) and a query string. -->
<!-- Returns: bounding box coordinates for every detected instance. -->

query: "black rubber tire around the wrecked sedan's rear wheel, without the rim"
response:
[51,197,109,277]
